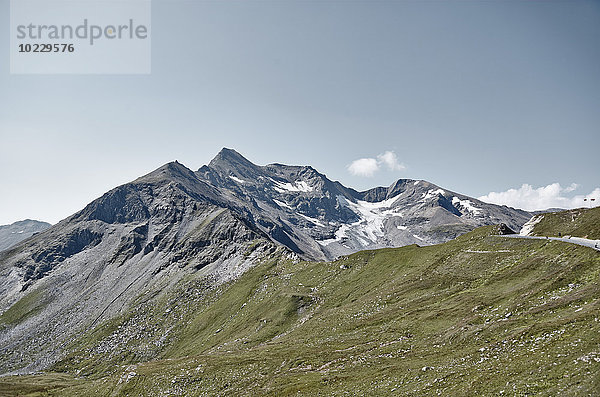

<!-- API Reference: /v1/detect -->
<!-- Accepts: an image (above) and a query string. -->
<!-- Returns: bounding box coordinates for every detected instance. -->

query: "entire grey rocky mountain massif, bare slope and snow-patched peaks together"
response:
[0,149,530,373]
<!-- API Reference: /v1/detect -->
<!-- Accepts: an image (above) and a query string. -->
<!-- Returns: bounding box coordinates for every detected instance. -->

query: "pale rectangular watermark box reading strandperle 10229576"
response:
[10,0,152,74]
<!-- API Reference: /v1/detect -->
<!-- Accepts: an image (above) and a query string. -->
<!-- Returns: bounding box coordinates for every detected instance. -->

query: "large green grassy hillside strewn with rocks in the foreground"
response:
[0,227,600,396]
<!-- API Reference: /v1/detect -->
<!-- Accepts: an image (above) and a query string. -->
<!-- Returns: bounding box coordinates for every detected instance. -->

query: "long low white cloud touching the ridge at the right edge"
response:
[479,183,600,211]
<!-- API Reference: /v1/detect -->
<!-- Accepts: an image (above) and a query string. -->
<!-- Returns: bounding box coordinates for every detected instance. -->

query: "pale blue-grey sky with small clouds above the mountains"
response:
[0,0,600,224]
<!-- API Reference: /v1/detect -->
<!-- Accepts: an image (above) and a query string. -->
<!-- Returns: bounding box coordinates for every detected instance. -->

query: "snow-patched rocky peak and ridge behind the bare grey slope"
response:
[196,149,531,260]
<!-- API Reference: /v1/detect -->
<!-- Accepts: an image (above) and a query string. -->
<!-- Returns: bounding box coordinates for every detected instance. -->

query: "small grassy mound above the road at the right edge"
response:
[531,207,600,240]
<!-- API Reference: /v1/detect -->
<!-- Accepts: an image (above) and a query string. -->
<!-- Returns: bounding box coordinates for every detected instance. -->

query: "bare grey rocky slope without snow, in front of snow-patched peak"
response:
[0,163,276,373]
